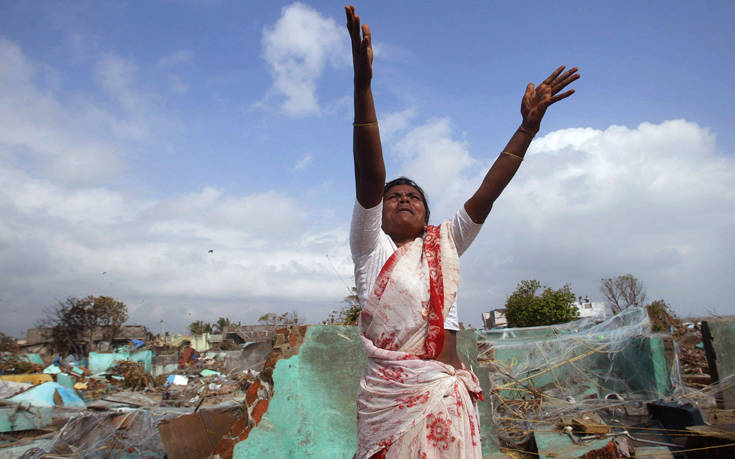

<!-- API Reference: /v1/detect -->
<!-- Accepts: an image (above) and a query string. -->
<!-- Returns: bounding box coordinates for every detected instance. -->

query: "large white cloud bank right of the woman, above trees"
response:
[457,120,735,323]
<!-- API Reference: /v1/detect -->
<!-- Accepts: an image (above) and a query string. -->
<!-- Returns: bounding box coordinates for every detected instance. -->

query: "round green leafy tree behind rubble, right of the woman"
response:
[505,280,579,327]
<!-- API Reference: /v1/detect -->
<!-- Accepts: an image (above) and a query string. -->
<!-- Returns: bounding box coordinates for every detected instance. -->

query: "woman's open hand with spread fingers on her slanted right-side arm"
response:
[524,66,579,132]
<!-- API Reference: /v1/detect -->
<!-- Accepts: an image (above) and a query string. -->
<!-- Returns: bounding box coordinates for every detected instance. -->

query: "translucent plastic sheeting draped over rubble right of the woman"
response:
[478,308,682,446]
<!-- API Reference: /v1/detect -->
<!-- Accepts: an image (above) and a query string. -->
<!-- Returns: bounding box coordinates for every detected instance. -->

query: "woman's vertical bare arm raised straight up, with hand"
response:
[345,6,385,208]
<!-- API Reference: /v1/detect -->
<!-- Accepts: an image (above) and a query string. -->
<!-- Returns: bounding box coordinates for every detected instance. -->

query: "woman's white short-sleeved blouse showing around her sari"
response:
[350,201,482,330]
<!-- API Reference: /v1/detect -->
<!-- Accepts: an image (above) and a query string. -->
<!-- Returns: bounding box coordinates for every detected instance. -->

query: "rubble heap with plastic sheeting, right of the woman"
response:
[478,308,735,457]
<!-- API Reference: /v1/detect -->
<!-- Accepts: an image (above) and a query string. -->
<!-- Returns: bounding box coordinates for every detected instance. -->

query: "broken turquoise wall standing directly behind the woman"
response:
[233,325,498,458]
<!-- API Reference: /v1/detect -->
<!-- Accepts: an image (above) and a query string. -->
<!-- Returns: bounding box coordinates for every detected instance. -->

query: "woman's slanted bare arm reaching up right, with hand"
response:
[464,65,579,223]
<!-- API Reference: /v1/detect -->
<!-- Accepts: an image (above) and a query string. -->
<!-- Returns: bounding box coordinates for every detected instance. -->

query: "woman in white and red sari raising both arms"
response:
[345,6,579,459]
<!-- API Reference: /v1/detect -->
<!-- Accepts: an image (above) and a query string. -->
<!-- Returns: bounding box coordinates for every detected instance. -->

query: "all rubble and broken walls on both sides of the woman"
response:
[0,316,735,459]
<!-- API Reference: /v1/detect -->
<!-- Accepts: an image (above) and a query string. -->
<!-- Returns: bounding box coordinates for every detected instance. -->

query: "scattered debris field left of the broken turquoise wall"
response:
[0,326,306,458]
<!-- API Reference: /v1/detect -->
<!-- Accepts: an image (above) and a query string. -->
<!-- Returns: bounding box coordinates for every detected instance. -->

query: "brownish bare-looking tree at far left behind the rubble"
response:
[39,295,128,355]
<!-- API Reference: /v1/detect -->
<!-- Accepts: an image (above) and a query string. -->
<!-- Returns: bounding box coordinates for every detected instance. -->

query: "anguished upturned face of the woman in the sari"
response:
[383,185,426,240]
